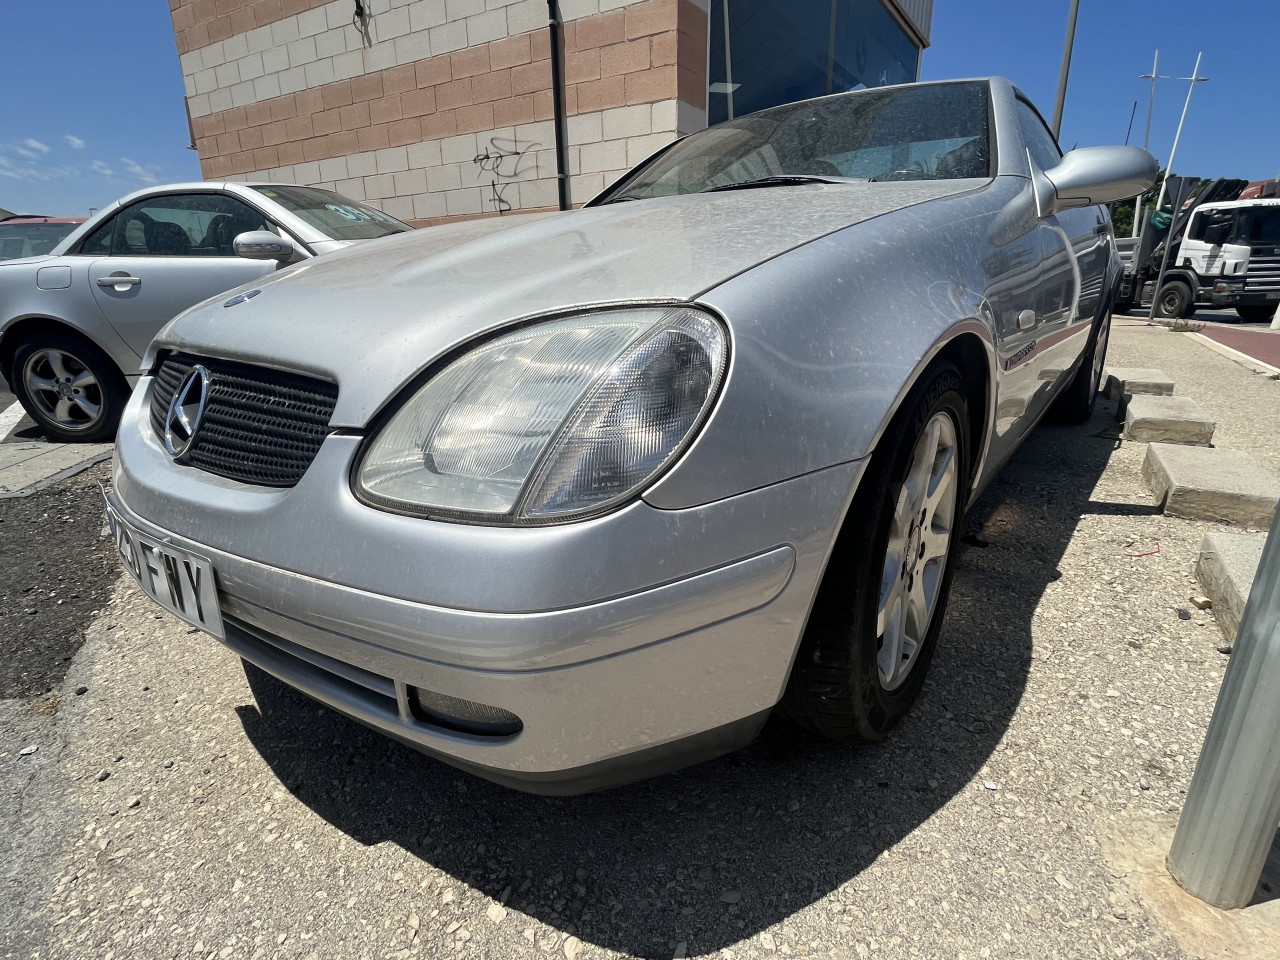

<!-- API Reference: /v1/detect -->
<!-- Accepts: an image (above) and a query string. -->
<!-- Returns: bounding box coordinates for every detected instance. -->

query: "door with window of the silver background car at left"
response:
[89,192,279,355]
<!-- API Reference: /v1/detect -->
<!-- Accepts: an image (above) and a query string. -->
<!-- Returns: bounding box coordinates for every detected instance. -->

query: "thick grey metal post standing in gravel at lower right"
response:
[1166,512,1280,909]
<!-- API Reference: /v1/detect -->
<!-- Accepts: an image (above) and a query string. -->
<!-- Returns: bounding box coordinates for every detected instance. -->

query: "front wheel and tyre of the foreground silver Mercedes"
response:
[783,364,970,742]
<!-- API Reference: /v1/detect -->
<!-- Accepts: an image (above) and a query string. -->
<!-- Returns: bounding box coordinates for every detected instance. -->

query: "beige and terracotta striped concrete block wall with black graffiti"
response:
[170,0,708,224]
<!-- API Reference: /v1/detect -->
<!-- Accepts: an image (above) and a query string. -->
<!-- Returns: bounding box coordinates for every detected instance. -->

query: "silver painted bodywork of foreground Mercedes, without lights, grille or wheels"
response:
[111,79,1153,792]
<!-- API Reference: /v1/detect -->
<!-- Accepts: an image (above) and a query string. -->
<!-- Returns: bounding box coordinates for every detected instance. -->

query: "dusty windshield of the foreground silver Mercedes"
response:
[600,82,992,202]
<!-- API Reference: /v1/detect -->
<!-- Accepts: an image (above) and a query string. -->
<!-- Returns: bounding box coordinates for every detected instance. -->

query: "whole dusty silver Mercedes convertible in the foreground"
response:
[108,79,1156,794]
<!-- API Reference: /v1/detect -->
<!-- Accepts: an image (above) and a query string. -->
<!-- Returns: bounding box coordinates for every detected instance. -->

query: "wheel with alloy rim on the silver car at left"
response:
[10,332,129,443]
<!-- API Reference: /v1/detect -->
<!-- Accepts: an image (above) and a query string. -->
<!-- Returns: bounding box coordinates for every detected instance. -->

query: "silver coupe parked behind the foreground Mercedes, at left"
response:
[0,183,412,442]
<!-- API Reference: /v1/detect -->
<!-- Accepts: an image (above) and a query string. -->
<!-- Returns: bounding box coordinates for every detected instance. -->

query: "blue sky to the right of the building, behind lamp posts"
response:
[920,0,1280,180]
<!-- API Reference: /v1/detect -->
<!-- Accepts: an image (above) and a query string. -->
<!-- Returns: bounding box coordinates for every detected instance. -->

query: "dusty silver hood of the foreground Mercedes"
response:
[157,180,986,429]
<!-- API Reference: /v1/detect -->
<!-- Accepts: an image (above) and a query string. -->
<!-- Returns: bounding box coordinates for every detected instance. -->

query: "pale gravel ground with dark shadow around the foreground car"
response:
[0,326,1280,960]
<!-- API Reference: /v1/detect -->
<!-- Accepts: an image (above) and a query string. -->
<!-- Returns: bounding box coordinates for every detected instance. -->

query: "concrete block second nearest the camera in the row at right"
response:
[1142,443,1280,530]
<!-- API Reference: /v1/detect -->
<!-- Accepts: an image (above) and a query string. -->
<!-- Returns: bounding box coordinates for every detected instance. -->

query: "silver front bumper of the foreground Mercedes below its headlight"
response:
[110,378,861,794]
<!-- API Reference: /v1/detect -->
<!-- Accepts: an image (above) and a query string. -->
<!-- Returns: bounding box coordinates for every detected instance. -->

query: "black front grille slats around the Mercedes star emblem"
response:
[151,353,338,486]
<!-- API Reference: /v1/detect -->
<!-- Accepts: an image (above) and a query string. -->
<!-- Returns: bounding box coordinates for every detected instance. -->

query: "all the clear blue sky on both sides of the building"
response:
[0,0,1280,216]
